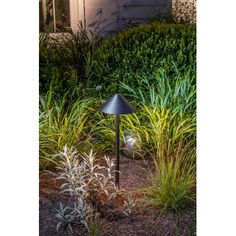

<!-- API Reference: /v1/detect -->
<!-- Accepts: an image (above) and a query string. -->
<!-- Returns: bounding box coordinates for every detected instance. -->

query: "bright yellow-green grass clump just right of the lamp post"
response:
[123,105,196,157]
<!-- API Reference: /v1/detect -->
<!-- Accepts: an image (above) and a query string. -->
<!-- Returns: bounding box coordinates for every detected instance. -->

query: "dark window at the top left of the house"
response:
[39,0,71,32]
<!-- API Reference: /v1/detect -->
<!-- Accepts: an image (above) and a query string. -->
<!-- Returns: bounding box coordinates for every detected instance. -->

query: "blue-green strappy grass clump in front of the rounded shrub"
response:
[121,67,196,114]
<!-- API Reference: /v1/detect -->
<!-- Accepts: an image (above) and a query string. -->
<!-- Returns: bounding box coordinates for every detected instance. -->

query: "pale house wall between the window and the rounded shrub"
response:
[78,0,171,35]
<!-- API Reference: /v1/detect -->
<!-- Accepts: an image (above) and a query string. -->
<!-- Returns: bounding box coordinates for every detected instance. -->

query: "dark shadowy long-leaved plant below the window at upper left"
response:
[39,24,101,96]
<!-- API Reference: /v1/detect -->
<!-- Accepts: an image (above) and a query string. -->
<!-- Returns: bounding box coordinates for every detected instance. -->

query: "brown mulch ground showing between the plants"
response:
[39,157,196,236]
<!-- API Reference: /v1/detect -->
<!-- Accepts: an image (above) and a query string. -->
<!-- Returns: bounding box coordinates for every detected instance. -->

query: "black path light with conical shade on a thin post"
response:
[100,94,135,188]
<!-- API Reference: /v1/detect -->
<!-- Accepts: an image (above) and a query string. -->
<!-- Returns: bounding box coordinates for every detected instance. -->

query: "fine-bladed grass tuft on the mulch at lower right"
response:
[142,143,196,214]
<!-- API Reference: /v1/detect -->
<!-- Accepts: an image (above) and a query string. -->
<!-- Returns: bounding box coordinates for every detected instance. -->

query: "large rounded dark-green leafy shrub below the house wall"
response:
[89,22,196,96]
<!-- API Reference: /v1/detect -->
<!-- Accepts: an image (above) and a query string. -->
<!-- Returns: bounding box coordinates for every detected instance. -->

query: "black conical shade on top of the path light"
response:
[101,94,135,115]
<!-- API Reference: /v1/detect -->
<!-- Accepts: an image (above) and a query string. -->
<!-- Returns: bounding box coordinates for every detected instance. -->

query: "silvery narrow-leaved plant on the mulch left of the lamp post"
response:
[52,145,136,235]
